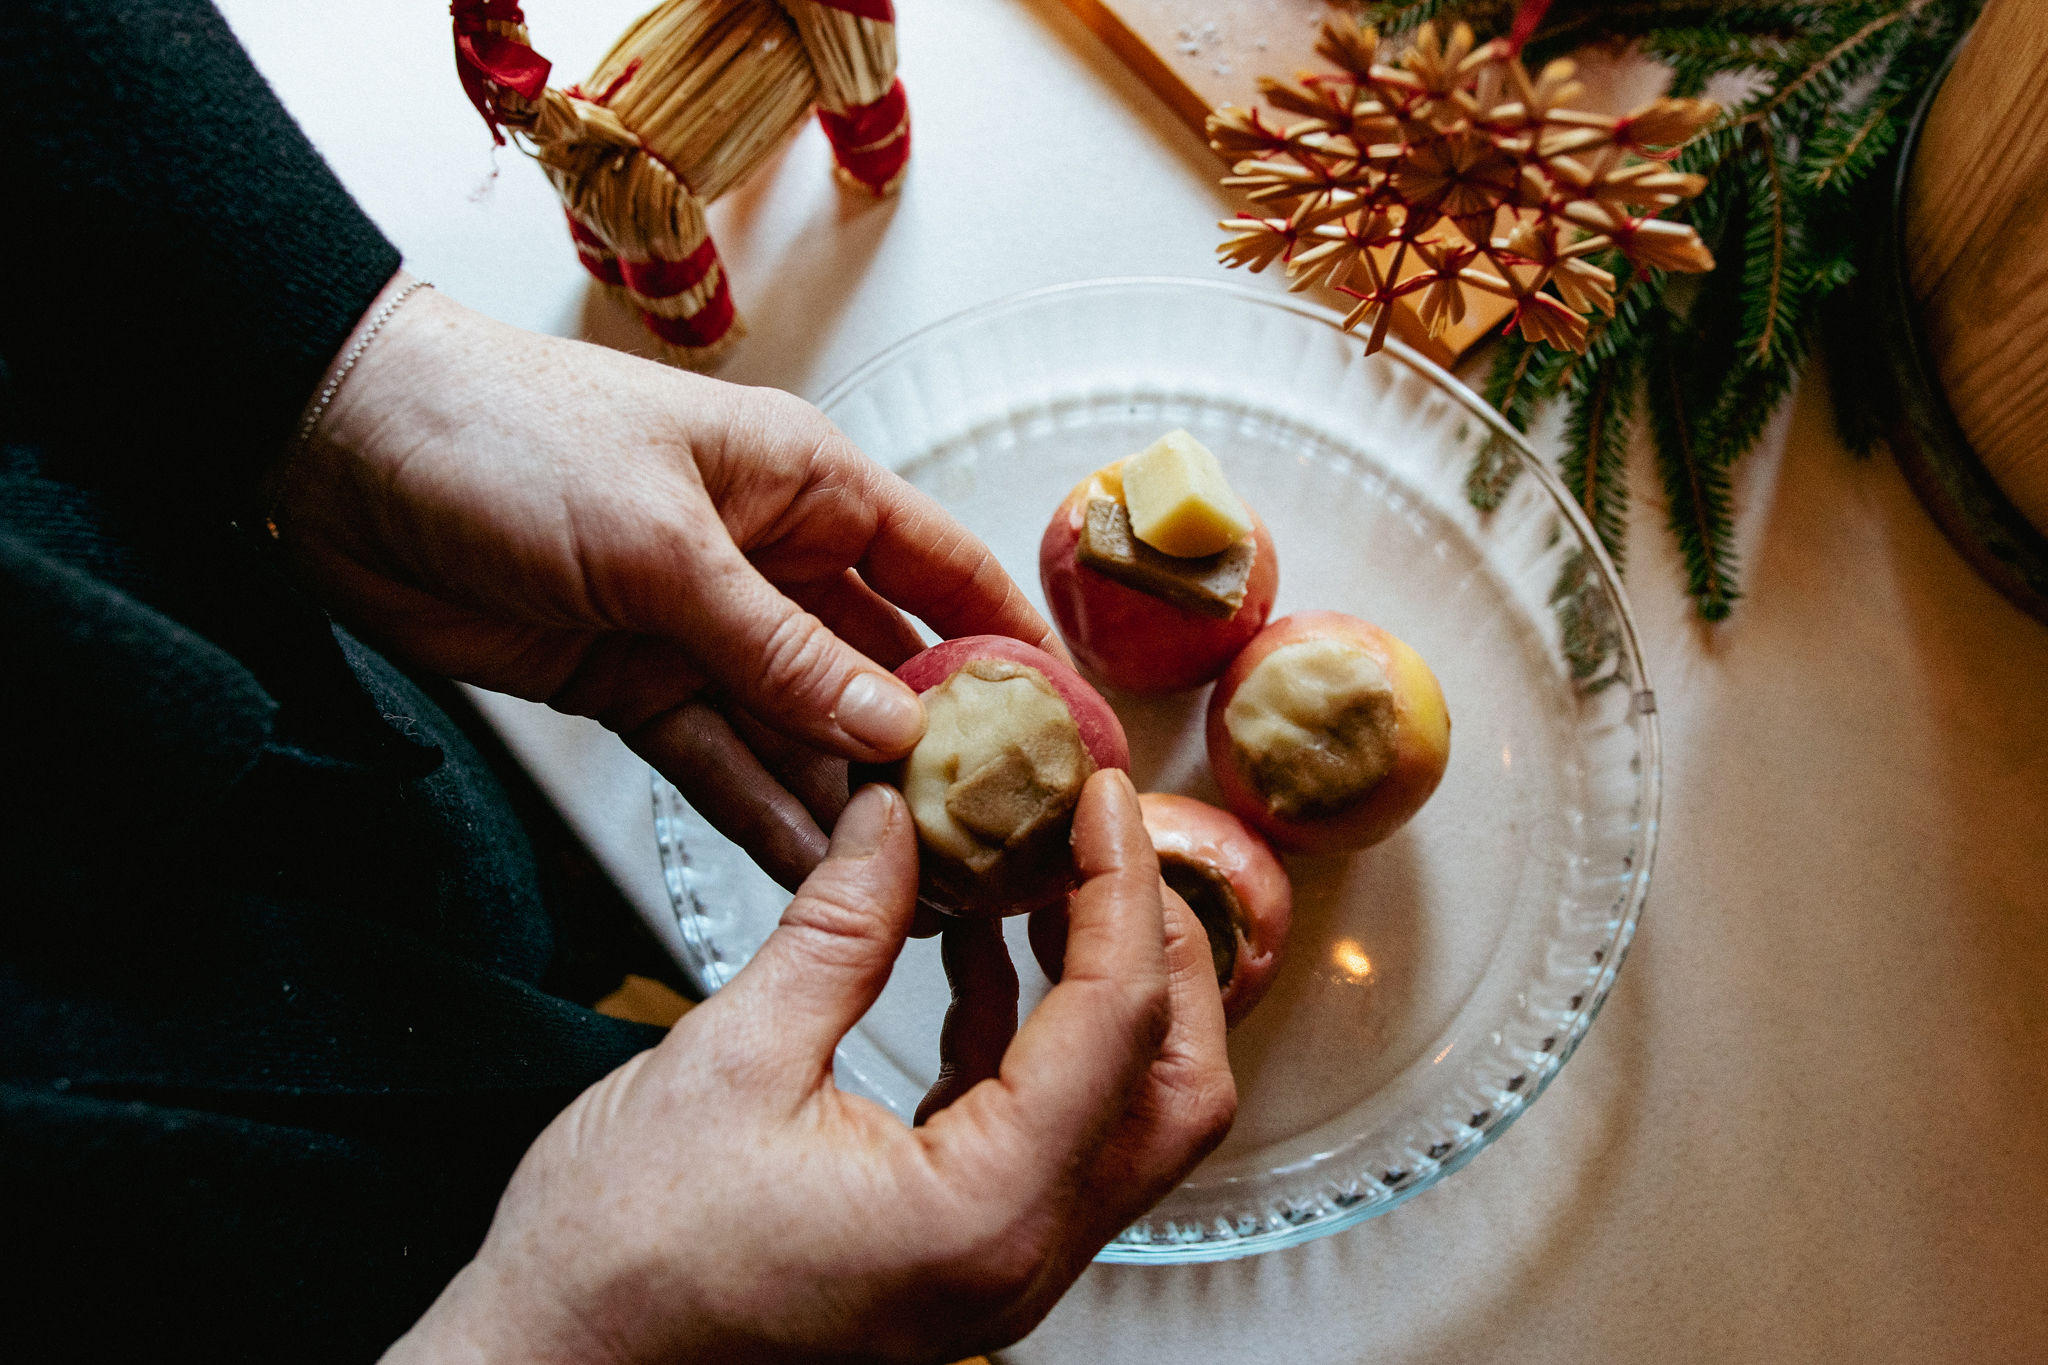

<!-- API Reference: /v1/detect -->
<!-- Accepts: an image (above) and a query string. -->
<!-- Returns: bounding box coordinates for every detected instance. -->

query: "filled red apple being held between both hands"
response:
[854,634,1130,915]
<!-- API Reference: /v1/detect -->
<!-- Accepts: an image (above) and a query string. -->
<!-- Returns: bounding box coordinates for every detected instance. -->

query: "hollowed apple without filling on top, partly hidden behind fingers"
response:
[1139,792,1294,1027]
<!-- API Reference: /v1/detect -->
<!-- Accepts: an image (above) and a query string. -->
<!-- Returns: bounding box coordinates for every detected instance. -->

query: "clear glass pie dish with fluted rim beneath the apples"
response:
[655,278,1659,1263]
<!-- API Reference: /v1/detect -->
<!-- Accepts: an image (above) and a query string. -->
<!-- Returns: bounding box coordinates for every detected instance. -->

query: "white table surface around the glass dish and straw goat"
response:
[223,0,2048,1365]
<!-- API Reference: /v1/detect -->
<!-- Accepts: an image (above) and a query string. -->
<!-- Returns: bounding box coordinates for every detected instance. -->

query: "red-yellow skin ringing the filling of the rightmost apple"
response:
[1208,612,1450,853]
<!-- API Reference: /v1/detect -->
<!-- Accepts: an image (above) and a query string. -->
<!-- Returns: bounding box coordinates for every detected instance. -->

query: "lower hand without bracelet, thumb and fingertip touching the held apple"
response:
[387,772,1237,1363]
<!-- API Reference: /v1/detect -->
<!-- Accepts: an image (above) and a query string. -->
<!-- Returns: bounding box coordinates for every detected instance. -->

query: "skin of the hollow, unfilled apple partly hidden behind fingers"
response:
[1139,792,1294,1027]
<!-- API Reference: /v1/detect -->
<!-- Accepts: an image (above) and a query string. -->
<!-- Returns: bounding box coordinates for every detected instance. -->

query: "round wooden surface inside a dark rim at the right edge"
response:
[1907,0,2048,532]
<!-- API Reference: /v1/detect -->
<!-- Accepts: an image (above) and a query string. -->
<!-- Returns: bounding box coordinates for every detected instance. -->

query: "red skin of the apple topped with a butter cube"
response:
[1038,467,1280,694]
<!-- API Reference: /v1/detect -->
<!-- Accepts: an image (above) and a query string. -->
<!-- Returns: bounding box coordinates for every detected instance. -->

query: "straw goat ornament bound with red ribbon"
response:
[451,0,909,368]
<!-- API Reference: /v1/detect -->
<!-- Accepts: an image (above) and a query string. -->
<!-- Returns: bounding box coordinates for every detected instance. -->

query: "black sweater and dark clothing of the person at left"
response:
[0,0,657,1359]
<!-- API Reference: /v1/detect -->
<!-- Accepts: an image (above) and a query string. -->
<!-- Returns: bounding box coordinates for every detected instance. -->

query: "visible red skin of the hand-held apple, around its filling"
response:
[852,634,1130,917]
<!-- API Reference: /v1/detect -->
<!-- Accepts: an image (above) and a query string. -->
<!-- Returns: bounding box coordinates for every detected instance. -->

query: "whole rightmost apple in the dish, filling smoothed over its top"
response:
[1208,612,1450,851]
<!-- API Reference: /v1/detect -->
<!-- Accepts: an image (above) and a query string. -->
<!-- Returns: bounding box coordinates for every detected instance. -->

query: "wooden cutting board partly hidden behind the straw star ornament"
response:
[1065,0,1509,364]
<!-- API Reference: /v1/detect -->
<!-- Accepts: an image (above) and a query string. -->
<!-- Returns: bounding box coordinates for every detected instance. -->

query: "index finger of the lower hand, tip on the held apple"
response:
[926,767,1167,1179]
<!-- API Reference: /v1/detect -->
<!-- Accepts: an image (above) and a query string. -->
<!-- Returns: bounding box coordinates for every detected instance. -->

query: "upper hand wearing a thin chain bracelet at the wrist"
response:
[272,274,1063,886]
